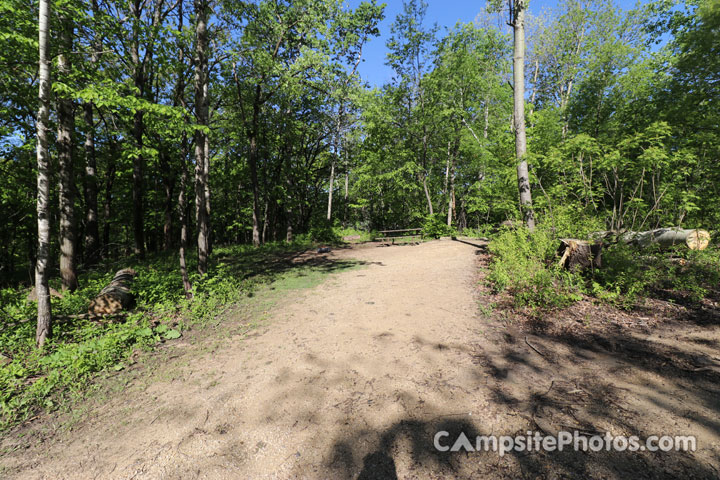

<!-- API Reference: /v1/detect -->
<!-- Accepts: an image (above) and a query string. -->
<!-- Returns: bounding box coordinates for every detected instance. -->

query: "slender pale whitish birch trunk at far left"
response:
[35,0,52,348]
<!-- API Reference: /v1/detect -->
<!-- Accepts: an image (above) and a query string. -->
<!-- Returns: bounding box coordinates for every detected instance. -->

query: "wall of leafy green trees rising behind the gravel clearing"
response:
[0,0,720,288]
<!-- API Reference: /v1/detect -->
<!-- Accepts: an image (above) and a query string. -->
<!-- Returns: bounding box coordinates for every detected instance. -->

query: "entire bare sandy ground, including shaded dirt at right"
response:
[0,240,720,479]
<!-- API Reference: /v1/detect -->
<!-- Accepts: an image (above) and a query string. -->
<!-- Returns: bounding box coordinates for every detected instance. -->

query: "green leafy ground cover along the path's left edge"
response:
[0,239,358,429]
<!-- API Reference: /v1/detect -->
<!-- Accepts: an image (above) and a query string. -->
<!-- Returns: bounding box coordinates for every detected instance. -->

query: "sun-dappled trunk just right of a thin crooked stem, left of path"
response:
[194,0,210,275]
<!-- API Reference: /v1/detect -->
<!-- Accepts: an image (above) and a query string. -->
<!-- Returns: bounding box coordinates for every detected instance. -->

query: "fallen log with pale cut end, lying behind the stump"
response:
[590,227,710,250]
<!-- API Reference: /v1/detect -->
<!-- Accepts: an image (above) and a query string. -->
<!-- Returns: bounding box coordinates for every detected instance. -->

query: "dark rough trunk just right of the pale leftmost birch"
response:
[57,16,77,291]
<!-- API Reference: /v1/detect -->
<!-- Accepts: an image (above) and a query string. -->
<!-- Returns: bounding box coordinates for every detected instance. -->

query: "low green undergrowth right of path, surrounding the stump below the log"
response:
[488,220,720,309]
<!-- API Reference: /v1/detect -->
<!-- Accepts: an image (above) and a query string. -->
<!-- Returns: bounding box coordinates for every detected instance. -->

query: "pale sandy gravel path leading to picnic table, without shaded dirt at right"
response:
[6,240,496,479]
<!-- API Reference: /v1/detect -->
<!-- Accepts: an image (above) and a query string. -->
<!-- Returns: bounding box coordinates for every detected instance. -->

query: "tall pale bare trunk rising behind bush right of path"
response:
[512,0,535,231]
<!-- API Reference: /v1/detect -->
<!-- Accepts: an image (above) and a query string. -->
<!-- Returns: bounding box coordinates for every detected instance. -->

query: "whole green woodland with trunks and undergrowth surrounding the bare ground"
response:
[0,0,720,429]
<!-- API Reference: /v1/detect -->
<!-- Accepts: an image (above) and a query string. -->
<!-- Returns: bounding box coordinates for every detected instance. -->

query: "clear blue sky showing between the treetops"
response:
[348,0,635,86]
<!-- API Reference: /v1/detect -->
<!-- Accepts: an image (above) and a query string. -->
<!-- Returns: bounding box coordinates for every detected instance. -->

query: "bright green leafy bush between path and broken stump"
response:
[488,228,582,308]
